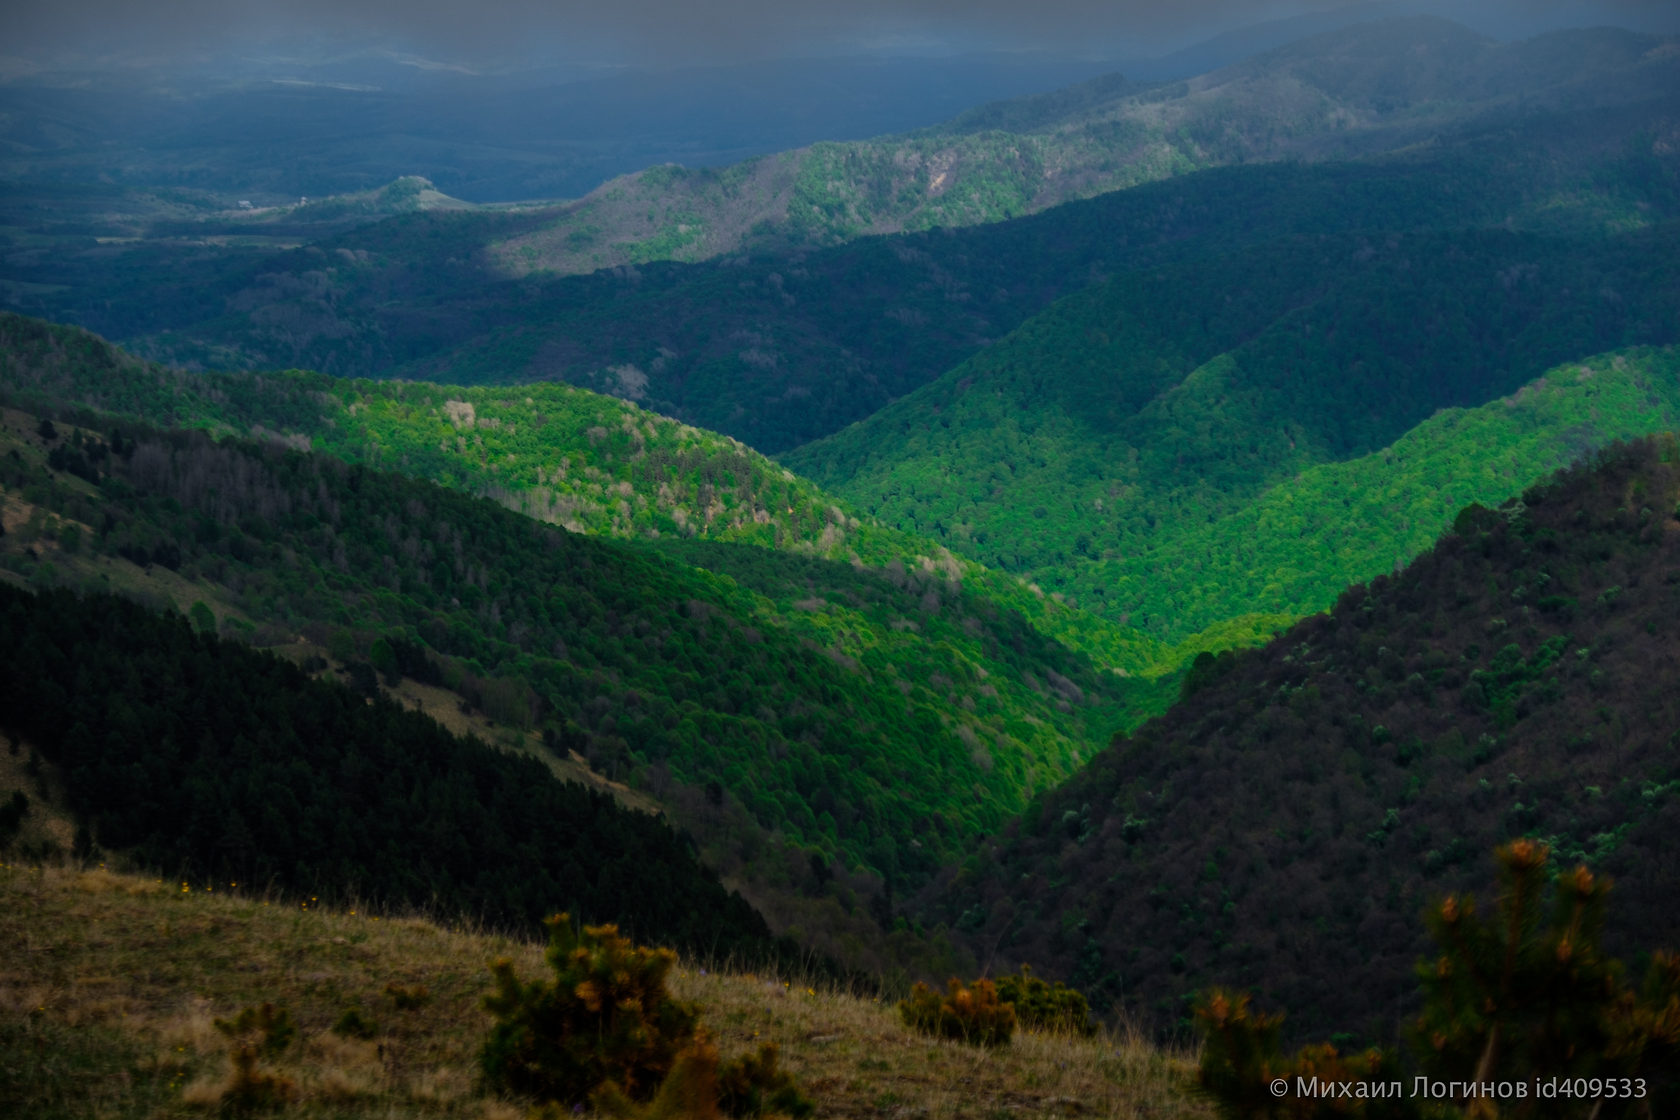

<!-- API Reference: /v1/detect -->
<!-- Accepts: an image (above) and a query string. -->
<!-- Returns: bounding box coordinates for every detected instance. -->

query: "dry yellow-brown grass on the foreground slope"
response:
[0,865,1208,1120]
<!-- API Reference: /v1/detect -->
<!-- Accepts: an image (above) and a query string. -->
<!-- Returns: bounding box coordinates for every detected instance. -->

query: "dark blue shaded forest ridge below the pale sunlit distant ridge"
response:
[5,27,1680,453]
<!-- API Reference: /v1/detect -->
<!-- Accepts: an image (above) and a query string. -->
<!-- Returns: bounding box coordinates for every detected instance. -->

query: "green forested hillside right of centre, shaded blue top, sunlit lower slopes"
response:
[783,225,1680,640]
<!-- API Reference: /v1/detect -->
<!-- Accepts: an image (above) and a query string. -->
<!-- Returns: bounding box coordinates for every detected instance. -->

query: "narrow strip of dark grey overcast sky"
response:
[0,0,1680,62]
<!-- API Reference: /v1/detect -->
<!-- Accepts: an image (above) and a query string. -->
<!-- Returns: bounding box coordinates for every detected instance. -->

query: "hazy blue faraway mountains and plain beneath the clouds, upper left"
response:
[0,50,1128,203]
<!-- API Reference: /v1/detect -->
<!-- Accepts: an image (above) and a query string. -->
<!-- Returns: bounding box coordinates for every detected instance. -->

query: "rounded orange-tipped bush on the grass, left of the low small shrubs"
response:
[480,913,699,1105]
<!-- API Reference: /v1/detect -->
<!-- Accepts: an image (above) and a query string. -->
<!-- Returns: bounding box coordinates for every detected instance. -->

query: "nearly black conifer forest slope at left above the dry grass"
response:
[0,581,776,959]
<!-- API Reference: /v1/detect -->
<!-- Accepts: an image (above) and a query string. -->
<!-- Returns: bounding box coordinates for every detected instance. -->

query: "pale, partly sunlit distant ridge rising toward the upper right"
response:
[491,17,1680,274]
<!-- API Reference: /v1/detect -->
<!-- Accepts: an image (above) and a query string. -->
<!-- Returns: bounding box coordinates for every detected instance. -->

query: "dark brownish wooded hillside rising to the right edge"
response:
[941,435,1680,1038]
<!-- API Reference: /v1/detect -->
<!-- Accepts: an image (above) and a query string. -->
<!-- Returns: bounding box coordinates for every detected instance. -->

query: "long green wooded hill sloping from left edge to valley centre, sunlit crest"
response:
[0,319,1209,987]
